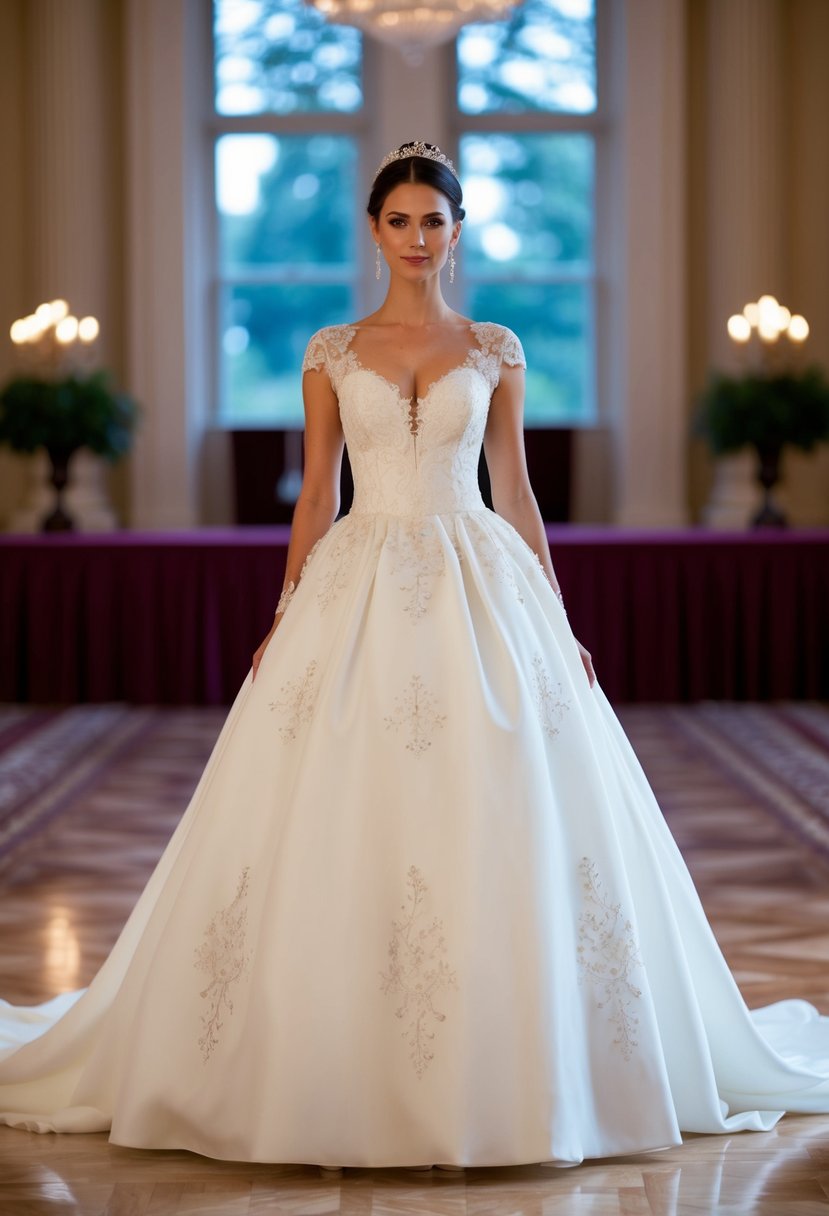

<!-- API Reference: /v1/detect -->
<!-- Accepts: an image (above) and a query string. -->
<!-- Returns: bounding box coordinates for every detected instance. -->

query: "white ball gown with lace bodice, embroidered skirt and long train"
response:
[0,323,829,1166]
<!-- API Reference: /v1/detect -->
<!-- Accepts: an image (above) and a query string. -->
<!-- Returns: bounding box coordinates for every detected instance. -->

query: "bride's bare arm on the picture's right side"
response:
[484,366,596,686]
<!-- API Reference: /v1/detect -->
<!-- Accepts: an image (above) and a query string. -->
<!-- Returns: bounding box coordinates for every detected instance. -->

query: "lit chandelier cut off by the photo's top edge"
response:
[308,0,520,61]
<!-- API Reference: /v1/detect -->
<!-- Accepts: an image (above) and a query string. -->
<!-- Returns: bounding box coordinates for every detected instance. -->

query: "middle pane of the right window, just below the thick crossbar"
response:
[461,133,593,275]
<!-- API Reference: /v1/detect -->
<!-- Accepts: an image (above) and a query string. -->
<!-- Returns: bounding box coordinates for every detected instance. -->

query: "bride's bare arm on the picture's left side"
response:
[252,371,344,680]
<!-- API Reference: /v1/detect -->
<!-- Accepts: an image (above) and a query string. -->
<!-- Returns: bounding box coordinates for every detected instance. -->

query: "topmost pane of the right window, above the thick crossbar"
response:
[457,0,596,114]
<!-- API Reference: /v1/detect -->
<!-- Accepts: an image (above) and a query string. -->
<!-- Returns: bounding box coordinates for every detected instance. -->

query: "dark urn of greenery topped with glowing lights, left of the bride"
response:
[0,302,137,531]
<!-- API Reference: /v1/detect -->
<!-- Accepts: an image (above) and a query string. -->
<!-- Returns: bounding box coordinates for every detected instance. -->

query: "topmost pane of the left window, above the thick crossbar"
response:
[213,0,362,114]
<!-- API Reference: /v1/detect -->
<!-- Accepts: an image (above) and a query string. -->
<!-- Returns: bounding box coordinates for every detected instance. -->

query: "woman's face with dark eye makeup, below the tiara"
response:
[371,181,461,282]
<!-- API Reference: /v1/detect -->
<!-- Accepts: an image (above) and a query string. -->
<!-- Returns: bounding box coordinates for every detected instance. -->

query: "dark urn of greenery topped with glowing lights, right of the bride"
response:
[695,297,829,528]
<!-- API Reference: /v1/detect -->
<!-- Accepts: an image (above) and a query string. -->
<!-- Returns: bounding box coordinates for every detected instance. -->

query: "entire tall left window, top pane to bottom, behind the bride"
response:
[213,0,363,427]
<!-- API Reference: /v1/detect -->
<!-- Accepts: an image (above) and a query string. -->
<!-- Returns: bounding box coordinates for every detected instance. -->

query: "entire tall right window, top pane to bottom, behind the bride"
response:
[457,0,597,426]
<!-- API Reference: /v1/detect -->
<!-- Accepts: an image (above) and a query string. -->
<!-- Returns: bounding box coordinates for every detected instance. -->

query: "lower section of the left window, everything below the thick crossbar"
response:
[216,134,357,426]
